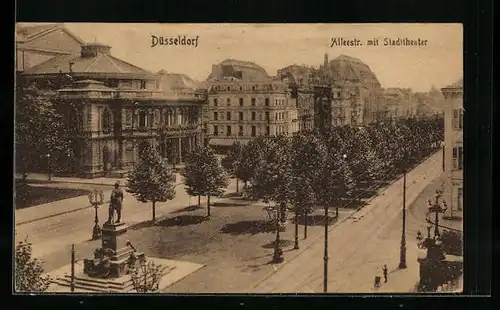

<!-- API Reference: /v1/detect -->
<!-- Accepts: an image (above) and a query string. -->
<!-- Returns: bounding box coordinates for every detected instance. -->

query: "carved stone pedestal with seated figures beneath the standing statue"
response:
[84,223,146,278]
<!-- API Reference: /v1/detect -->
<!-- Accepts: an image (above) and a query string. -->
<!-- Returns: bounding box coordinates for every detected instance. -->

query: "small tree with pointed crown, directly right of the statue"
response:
[127,141,175,222]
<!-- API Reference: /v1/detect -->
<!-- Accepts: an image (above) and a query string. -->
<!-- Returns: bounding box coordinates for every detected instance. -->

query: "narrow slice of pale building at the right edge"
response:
[441,80,465,219]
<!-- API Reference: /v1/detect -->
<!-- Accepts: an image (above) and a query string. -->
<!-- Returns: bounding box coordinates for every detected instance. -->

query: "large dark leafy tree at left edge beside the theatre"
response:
[15,85,73,177]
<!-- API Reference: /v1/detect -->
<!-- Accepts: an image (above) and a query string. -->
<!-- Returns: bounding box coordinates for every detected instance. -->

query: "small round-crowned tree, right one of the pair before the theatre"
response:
[184,146,228,218]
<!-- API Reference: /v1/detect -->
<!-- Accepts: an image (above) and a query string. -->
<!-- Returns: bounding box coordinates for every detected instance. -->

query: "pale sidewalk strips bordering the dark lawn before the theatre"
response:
[15,175,184,225]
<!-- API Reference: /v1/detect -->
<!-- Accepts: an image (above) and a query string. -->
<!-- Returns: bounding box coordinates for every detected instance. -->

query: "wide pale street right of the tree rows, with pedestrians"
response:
[253,153,442,293]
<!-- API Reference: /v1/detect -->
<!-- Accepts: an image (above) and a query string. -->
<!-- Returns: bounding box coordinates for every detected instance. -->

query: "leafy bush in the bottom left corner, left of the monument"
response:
[14,239,51,293]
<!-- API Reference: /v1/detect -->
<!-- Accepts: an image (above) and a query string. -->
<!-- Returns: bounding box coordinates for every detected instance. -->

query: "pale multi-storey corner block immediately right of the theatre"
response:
[203,59,298,151]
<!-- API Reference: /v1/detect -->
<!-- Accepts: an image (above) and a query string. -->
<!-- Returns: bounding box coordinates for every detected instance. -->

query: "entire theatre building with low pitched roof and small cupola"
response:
[22,43,206,178]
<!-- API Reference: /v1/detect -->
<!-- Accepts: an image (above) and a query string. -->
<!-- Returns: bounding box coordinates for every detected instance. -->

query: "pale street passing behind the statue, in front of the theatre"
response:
[16,180,240,257]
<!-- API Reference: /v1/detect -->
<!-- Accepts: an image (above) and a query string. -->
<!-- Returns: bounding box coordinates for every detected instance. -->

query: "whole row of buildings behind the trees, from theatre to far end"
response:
[16,24,446,177]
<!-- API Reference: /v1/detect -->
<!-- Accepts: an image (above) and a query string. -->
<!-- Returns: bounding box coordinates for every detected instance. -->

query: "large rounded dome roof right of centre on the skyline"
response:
[328,55,380,88]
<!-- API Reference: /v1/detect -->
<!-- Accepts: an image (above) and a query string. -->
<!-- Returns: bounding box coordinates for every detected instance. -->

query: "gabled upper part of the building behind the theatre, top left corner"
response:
[15,23,83,72]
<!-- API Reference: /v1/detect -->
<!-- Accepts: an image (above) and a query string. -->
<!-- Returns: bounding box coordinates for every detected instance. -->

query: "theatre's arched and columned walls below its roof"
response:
[58,81,203,178]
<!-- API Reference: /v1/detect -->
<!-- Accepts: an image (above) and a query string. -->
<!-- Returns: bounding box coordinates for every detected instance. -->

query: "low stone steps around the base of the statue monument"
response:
[54,266,176,293]
